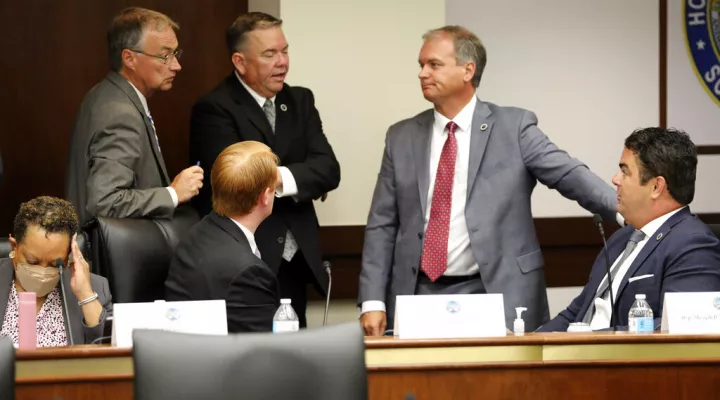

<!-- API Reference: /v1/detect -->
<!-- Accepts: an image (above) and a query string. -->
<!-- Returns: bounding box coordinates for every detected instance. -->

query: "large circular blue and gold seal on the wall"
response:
[683,0,720,106]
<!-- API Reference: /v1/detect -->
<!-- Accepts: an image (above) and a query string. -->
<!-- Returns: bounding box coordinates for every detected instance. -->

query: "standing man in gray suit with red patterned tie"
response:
[359,26,617,335]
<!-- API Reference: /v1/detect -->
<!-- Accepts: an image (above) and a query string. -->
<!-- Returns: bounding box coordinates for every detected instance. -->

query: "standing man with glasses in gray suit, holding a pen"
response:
[65,7,203,224]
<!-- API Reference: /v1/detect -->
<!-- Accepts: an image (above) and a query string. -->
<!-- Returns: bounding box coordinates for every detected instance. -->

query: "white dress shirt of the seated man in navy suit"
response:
[590,207,685,330]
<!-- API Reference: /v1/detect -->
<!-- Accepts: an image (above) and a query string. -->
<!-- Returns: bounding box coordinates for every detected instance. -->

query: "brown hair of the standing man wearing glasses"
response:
[107,7,180,72]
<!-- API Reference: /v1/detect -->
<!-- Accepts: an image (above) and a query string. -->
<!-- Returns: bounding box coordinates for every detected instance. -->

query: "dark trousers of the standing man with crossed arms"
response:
[278,250,317,328]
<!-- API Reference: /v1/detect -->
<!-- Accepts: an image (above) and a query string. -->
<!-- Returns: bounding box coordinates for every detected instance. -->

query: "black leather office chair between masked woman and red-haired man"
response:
[90,207,199,303]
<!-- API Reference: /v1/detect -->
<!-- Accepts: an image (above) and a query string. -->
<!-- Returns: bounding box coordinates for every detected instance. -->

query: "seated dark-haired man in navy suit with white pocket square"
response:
[538,128,720,332]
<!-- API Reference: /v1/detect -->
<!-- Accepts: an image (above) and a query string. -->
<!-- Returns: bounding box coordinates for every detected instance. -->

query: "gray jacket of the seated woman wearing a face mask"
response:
[0,258,112,344]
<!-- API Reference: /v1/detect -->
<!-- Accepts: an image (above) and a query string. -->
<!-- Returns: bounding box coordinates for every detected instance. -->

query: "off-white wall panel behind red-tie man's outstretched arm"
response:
[446,0,659,217]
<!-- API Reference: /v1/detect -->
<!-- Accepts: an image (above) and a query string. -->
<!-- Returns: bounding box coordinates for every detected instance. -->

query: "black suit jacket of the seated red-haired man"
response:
[165,212,280,333]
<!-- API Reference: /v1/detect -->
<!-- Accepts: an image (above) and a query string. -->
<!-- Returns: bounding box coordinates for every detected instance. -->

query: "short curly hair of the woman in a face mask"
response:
[13,196,78,243]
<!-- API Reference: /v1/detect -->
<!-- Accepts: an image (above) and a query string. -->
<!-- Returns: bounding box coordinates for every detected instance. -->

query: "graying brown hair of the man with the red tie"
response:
[423,25,487,88]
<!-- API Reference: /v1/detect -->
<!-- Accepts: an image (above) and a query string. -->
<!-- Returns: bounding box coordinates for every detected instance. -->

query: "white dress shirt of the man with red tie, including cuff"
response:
[361,96,480,313]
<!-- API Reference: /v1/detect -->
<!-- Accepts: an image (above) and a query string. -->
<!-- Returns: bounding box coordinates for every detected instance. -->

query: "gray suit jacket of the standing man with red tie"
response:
[358,100,617,331]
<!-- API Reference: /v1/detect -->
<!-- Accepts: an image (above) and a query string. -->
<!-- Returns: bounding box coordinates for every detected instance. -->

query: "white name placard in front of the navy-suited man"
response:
[661,292,720,334]
